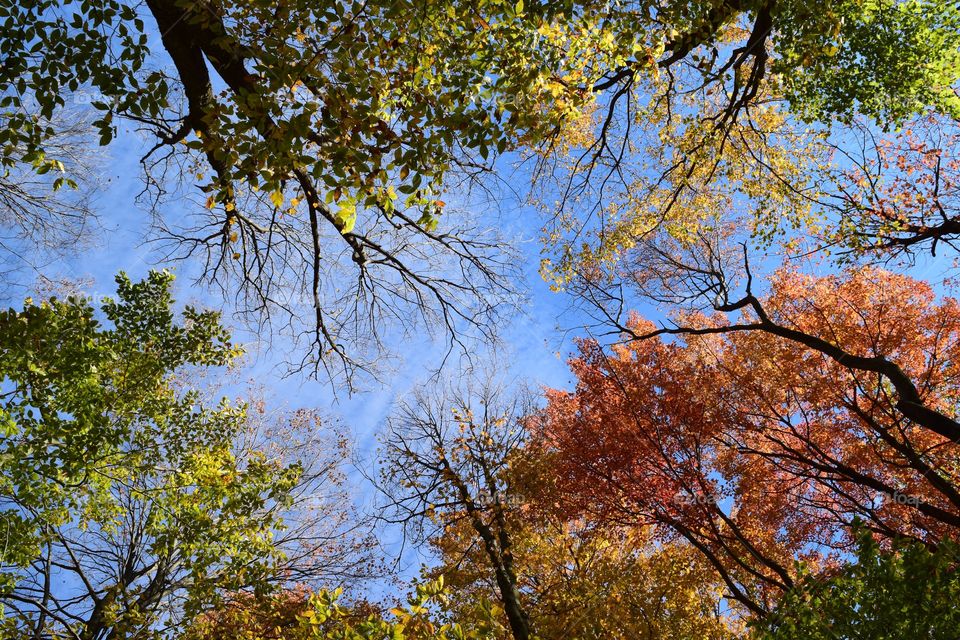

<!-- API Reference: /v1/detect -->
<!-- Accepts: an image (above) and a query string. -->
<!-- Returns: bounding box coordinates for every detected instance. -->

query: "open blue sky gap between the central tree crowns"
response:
[4,115,624,576]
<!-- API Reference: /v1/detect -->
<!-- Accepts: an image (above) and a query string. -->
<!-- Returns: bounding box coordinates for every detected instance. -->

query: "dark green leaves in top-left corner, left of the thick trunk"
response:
[0,0,153,169]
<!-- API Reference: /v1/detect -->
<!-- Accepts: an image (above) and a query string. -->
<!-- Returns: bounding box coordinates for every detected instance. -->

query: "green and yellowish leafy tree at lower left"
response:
[0,272,372,640]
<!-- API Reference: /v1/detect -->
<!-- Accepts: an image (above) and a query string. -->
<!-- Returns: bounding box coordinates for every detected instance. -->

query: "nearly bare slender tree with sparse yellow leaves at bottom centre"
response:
[382,378,536,640]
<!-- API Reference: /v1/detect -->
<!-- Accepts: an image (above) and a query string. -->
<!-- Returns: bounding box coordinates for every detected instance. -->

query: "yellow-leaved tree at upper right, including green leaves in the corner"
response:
[538,1,960,286]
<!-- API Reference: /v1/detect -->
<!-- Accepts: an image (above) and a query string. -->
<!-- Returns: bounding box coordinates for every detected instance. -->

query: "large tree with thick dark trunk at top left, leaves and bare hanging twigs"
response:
[0,0,617,380]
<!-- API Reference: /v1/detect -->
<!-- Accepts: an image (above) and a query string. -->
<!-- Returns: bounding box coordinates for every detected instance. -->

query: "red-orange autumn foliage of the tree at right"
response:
[540,269,960,613]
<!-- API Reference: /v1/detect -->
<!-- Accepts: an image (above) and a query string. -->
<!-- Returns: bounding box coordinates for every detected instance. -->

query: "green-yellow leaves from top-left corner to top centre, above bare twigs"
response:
[0,0,633,232]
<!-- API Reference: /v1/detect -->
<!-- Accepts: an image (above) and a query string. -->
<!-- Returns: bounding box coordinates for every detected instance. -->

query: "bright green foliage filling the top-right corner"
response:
[773,0,960,127]
